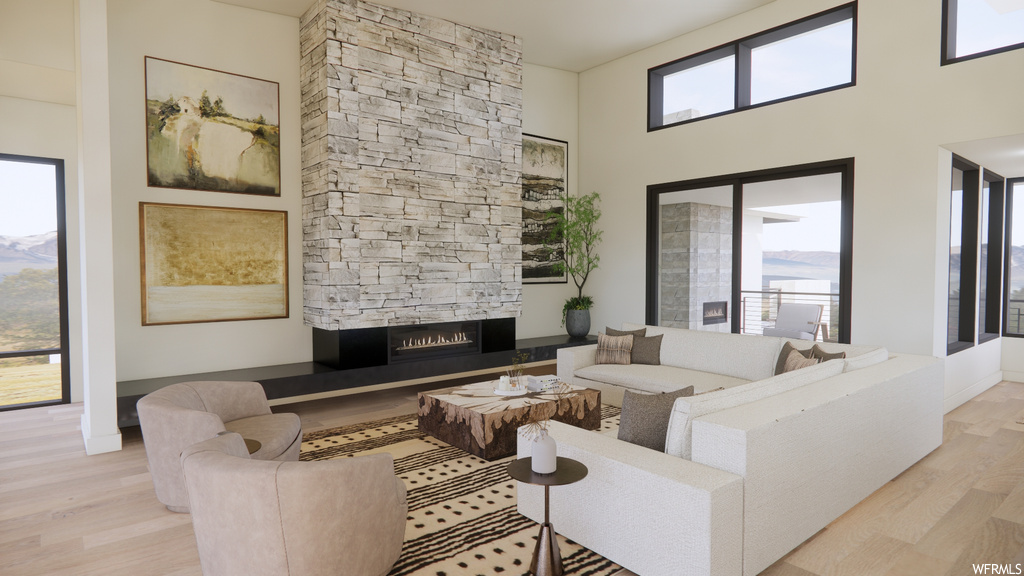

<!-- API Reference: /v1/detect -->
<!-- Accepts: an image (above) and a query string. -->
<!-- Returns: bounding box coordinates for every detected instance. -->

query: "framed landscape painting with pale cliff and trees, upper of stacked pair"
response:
[145,56,281,196]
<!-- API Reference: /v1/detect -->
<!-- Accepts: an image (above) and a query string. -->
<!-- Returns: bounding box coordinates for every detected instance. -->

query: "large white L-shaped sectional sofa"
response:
[518,325,943,576]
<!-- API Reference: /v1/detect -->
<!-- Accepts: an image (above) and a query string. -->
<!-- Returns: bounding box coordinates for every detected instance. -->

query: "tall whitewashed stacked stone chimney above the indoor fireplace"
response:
[301,0,522,330]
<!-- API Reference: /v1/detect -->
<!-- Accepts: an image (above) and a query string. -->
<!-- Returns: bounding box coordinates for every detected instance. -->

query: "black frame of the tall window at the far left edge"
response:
[0,153,71,412]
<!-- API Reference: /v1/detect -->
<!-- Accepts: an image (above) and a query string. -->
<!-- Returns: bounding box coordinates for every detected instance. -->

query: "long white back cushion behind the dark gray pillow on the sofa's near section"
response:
[665,361,845,460]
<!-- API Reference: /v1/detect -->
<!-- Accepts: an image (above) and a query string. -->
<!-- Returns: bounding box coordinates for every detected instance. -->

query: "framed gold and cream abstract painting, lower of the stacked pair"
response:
[139,202,288,326]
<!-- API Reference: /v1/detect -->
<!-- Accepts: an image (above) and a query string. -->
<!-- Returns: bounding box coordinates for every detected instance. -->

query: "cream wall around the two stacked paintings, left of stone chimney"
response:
[109,0,312,381]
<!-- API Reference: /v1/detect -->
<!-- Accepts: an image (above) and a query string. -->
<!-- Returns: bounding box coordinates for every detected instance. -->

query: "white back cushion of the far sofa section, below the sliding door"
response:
[623,323,782,380]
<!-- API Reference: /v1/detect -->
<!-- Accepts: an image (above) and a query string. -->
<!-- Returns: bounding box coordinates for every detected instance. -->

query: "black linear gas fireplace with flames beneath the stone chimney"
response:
[313,318,515,370]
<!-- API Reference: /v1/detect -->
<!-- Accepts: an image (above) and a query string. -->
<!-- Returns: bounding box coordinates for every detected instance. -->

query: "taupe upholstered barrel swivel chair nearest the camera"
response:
[181,434,409,576]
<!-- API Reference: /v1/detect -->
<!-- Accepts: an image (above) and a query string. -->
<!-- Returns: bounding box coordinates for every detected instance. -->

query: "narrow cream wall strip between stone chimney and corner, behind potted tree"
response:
[516,64,577,338]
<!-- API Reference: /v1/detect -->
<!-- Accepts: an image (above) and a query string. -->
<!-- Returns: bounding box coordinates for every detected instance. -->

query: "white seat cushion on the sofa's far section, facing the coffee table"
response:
[573,364,749,394]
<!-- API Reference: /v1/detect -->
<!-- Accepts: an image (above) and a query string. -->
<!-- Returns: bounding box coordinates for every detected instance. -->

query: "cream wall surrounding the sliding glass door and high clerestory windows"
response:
[580,0,1024,403]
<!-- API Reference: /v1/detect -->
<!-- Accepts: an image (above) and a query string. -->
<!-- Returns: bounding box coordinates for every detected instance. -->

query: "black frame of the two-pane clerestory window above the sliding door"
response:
[647,1,857,132]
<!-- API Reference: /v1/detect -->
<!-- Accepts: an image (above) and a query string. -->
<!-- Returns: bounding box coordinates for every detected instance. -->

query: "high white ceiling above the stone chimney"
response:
[215,0,773,72]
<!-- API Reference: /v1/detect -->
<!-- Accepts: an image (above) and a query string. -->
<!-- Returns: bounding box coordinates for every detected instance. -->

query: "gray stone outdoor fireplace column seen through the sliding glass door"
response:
[659,202,735,332]
